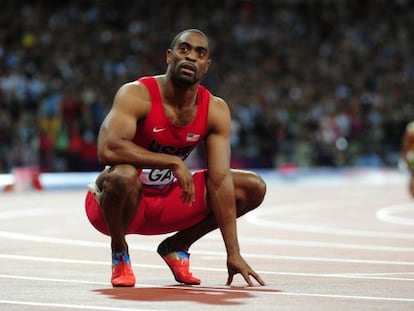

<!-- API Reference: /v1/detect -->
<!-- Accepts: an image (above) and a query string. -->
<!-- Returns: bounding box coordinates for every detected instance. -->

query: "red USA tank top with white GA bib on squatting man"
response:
[133,77,210,189]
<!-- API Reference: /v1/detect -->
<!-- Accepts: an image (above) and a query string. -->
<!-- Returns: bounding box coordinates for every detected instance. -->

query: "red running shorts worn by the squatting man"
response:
[85,170,207,235]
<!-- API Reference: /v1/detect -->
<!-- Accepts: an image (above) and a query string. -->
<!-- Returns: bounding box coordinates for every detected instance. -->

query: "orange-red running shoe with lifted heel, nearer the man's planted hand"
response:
[157,241,201,285]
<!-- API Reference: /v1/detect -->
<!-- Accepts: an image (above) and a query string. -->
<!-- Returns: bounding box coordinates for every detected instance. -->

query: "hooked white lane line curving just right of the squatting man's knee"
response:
[245,205,414,240]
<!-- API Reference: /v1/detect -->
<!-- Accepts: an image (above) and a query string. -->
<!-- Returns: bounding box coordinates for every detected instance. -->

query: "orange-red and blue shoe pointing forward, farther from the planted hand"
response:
[111,251,135,287]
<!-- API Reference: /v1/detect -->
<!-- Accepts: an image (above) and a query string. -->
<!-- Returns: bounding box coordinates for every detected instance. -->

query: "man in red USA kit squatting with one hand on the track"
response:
[86,29,266,287]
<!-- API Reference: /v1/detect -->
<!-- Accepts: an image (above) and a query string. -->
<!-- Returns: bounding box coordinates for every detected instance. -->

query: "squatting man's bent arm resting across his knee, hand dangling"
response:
[98,82,195,204]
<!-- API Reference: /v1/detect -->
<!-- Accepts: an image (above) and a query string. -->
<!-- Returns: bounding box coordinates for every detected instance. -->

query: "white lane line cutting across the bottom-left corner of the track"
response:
[0,300,158,311]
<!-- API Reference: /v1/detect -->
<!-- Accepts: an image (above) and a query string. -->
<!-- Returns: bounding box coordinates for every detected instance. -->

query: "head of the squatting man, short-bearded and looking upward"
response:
[167,32,211,85]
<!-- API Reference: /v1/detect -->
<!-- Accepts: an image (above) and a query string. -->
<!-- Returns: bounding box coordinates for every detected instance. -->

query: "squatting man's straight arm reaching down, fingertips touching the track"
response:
[206,99,264,286]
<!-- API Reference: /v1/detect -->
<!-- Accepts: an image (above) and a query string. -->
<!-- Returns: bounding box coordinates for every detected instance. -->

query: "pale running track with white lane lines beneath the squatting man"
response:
[0,170,414,311]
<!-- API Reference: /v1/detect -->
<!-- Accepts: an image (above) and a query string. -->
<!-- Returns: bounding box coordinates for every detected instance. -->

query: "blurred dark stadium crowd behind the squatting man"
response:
[0,0,414,173]
